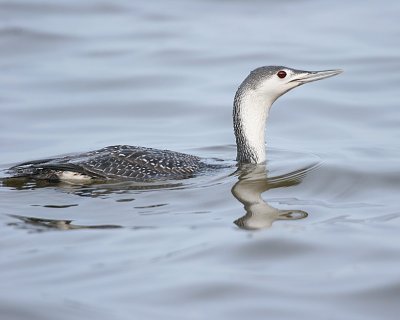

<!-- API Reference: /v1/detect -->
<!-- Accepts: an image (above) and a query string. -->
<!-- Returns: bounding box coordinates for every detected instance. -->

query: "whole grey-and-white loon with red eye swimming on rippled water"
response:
[9,66,342,182]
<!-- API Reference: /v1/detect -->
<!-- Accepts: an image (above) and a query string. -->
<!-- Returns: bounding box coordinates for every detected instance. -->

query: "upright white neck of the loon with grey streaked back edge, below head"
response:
[233,89,274,163]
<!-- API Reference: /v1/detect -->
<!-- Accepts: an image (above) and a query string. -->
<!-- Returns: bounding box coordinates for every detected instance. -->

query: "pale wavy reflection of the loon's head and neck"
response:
[232,164,312,230]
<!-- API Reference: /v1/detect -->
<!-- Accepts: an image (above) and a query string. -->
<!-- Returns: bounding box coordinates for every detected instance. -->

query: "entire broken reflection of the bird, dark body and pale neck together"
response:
[2,164,315,230]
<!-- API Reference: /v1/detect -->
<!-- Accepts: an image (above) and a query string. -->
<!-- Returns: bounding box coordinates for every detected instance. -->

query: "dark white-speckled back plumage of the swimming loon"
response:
[10,145,206,181]
